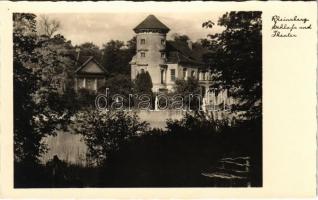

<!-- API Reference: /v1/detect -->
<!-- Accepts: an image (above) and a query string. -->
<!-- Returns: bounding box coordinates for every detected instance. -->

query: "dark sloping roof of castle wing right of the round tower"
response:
[166,41,208,67]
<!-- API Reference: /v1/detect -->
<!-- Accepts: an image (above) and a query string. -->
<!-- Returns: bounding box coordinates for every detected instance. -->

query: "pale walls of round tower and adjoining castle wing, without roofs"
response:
[131,31,212,92]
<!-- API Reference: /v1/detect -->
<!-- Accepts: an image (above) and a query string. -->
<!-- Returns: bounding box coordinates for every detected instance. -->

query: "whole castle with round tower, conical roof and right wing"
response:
[130,15,212,92]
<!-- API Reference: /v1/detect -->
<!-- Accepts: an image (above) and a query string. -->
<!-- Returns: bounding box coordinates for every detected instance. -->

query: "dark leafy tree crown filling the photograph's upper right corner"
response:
[202,11,262,117]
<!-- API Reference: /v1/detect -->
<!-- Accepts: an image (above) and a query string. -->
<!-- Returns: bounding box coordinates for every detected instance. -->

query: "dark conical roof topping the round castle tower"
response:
[134,15,170,33]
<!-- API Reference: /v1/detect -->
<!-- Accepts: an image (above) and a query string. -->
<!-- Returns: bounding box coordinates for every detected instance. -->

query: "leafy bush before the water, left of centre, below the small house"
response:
[77,110,148,165]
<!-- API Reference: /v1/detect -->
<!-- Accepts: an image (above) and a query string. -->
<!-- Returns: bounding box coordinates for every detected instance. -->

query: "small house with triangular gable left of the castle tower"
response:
[74,56,107,92]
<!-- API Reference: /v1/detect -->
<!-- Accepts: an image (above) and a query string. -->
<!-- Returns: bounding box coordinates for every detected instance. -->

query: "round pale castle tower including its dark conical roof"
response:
[132,15,169,91]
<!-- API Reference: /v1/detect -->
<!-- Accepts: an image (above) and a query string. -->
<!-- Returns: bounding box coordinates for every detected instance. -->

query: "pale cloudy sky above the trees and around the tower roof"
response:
[38,12,223,47]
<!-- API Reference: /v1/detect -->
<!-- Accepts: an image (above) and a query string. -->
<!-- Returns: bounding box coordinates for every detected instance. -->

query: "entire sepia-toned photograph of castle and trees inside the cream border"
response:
[12,10,263,189]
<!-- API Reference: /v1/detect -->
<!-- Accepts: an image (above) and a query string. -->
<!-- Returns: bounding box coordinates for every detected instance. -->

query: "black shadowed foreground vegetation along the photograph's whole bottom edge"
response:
[15,113,262,188]
